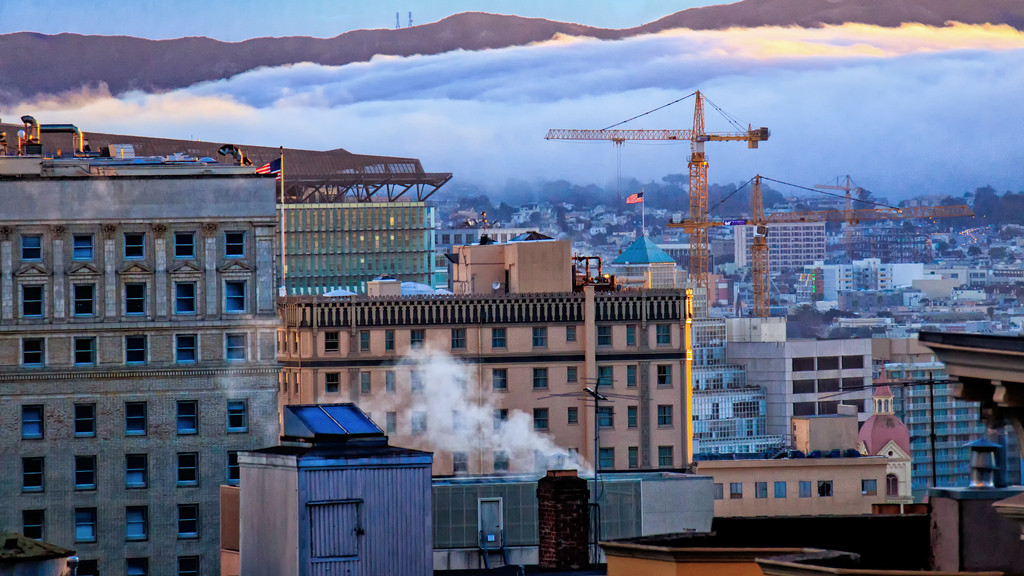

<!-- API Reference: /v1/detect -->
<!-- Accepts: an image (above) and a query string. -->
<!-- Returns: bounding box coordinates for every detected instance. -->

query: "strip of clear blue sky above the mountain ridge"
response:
[0,0,729,42]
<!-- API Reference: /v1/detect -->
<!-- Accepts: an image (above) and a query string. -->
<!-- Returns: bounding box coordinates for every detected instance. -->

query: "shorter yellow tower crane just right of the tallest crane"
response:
[670,174,974,318]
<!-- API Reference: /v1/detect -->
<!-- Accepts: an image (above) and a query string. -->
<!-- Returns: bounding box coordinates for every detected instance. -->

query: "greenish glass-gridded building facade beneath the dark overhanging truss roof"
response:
[279,202,434,294]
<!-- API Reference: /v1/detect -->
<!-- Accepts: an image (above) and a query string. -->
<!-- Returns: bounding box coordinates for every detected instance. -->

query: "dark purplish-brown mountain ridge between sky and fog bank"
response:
[0,0,1024,104]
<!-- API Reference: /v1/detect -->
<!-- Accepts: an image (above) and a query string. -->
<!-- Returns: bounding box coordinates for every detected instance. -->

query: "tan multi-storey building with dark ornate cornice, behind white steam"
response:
[278,235,691,475]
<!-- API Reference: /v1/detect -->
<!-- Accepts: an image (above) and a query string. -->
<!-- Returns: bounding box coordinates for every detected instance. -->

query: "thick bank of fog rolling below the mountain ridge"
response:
[8,25,1024,199]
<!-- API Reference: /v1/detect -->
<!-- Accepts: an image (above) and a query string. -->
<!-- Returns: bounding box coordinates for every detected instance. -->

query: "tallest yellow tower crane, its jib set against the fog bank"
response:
[545,90,769,307]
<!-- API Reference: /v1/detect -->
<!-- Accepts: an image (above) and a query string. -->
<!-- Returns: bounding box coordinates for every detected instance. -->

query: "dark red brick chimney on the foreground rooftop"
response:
[537,470,590,570]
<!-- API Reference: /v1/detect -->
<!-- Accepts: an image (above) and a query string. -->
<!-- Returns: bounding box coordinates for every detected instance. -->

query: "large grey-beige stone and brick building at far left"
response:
[0,142,279,575]
